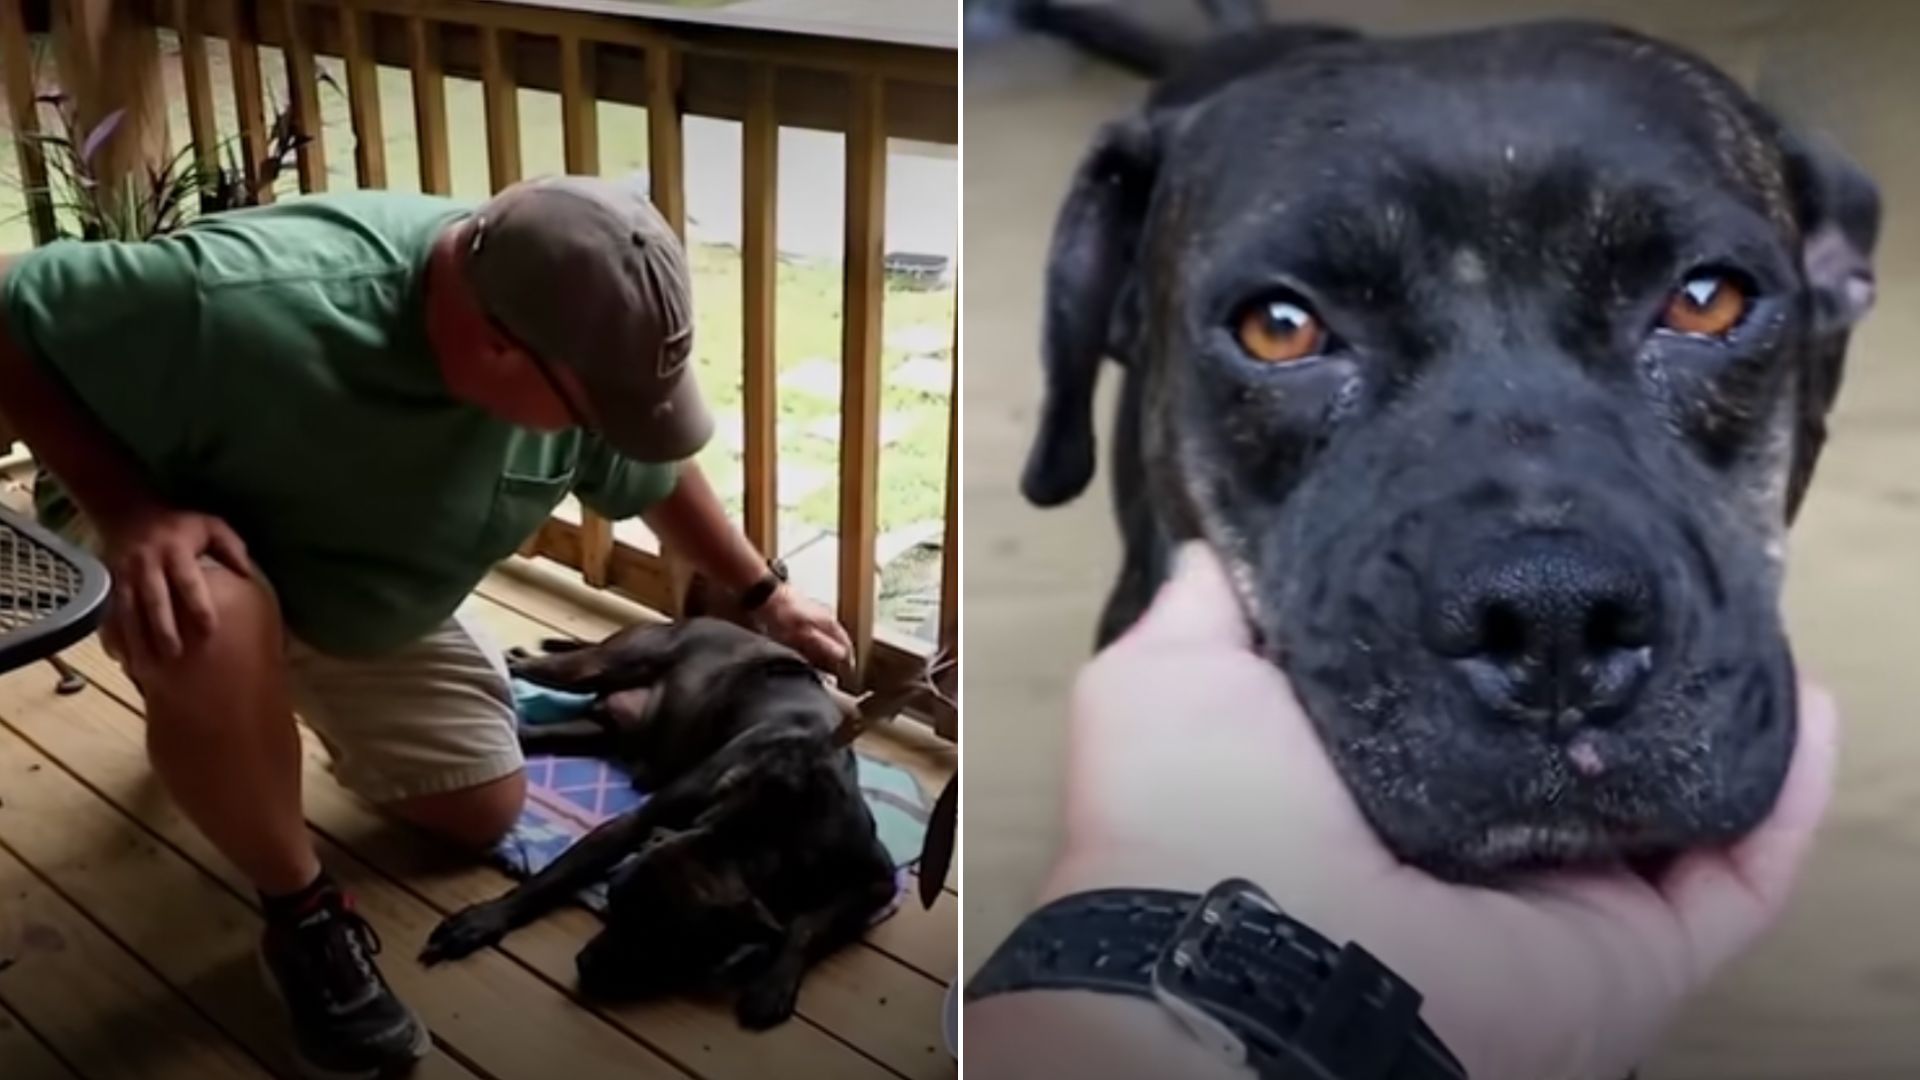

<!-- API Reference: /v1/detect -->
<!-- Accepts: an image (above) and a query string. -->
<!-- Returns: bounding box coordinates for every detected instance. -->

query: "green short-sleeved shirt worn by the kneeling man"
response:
[4,192,678,655]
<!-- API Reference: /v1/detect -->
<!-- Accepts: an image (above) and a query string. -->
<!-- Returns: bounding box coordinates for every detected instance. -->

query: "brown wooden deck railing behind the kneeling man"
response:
[0,0,960,738]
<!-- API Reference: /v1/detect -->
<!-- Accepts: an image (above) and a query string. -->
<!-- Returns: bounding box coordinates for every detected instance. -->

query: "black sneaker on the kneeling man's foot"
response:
[261,890,432,1080]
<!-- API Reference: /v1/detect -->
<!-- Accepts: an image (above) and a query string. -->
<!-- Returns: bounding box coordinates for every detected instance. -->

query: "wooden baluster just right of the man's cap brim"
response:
[739,65,780,555]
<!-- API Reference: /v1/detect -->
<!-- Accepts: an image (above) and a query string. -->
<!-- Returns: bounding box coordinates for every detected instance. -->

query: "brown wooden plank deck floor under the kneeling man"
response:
[0,557,958,1080]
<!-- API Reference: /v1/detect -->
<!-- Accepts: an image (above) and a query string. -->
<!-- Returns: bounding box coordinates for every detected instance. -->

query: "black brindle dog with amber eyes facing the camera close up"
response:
[1023,0,1880,880]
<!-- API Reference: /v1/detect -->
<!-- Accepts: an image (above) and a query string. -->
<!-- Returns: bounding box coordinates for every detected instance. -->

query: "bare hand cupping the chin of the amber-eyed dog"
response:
[1029,546,1836,1080]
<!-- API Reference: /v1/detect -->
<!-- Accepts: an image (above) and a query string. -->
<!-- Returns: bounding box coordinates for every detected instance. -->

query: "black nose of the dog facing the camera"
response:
[1425,532,1659,728]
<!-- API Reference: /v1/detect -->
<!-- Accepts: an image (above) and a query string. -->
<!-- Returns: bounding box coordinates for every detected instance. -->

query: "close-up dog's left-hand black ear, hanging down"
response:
[1021,113,1158,505]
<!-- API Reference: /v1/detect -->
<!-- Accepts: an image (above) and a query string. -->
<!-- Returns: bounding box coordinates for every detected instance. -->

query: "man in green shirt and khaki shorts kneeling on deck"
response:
[0,177,849,1076]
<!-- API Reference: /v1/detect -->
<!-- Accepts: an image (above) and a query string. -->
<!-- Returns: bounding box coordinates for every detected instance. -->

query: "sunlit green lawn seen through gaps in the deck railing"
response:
[0,37,954,544]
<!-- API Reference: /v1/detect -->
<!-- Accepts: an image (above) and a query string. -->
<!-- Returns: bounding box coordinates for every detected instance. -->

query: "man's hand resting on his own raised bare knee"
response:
[104,509,252,659]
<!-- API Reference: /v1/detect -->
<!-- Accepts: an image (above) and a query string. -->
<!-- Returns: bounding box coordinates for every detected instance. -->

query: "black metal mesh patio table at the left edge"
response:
[0,505,108,694]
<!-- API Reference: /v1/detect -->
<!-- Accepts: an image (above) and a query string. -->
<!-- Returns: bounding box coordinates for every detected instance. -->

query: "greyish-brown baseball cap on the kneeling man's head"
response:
[467,177,714,463]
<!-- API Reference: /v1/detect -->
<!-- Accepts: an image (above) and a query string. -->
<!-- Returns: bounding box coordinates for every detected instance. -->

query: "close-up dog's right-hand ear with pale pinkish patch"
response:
[1780,133,1880,521]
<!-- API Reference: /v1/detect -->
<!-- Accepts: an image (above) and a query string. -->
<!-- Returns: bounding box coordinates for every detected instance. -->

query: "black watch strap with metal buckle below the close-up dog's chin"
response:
[966,880,1467,1080]
